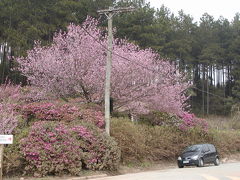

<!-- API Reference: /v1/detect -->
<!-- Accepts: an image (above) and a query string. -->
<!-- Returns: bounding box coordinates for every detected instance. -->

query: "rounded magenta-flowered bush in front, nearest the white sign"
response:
[20,121,84,176]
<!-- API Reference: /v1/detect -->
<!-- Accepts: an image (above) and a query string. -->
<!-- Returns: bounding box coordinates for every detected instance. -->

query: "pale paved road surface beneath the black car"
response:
[98,163,240,180]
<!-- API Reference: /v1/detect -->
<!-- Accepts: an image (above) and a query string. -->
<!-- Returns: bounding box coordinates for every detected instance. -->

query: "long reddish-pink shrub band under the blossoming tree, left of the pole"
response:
[22,102,105,128]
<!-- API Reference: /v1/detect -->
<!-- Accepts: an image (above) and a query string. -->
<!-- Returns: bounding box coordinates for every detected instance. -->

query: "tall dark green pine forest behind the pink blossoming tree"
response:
[0,0,240,115]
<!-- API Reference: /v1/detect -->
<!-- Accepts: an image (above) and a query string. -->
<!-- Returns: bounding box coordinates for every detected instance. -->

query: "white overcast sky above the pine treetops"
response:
[146,0,240,21]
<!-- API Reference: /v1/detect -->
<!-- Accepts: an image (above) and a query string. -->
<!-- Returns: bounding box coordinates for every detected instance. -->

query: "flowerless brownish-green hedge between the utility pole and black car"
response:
[111,118,223,163]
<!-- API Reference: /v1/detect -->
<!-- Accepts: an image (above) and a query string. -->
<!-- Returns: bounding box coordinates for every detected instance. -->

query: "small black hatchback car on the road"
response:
[178,144,220,168]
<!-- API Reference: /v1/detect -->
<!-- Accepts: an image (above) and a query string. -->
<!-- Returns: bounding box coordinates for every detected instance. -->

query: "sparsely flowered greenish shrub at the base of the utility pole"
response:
[72,122,120,170]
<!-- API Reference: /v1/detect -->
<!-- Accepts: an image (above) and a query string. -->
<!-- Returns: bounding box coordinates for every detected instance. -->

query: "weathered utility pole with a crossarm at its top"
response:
[97,7,135,135]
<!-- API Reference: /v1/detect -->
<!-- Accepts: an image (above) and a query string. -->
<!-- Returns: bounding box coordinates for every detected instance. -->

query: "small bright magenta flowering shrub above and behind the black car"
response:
[179,112,208,131]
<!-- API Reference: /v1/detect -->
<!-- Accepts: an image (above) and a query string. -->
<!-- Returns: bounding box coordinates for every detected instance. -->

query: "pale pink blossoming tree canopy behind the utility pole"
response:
[17,17,189,115]
